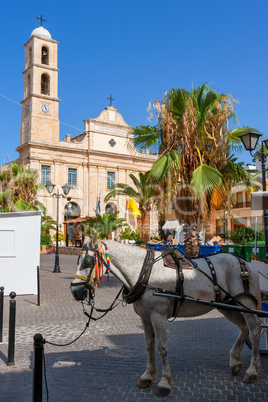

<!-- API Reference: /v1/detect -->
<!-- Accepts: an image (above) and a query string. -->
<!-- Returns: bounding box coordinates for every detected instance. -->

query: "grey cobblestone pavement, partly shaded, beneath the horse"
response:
[0,255,268,402]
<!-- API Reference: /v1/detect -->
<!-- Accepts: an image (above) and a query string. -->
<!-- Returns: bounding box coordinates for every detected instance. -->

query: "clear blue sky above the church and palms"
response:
[0,0,268,165]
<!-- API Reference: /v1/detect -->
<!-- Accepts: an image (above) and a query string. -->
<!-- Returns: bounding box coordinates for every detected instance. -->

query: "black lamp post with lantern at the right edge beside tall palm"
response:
[240,131,268,262]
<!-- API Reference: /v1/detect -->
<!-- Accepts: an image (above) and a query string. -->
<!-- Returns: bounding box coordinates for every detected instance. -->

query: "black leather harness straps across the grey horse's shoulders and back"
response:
[123,248,258,318]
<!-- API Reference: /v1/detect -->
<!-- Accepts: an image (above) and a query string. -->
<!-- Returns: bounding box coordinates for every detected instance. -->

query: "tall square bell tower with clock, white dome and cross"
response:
[18,21,60,147]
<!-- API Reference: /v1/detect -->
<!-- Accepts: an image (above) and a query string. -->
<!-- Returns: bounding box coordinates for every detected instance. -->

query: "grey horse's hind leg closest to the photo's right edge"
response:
[243,314,261,383]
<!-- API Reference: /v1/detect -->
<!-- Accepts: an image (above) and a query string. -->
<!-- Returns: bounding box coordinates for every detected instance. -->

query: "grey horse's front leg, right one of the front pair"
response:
[152,314,172,396]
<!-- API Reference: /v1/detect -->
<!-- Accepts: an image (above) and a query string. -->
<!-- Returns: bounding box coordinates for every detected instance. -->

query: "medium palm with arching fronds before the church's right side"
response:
[104,172,157,239]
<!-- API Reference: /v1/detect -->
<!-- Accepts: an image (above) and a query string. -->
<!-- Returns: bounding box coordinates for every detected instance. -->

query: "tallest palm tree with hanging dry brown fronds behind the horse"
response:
[132,84,258,257]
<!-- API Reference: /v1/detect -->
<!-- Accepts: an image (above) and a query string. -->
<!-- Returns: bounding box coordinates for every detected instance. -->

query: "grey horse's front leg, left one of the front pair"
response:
[137,318,157,388]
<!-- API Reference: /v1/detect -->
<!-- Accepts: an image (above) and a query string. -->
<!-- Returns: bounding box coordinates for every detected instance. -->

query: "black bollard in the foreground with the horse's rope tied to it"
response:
[33,334,44,402]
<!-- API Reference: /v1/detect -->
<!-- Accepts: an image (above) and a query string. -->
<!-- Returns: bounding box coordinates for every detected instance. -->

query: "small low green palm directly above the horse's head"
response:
[86,211,127,239]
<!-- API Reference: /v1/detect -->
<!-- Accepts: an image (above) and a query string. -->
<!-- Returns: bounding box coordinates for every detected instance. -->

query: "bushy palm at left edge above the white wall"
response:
[0,162,44,212]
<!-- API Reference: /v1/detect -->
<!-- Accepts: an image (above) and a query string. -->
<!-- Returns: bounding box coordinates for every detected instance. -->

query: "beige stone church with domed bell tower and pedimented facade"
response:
[17,21,158,239]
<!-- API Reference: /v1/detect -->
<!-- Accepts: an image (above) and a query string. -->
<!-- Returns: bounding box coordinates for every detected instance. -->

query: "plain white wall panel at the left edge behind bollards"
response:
[0,211,41,295]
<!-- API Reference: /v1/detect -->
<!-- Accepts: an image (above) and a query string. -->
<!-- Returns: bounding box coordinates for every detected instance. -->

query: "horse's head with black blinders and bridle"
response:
[70,233,98,301]
